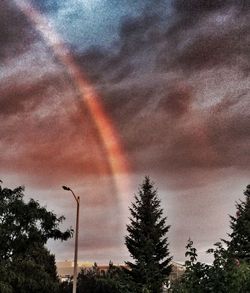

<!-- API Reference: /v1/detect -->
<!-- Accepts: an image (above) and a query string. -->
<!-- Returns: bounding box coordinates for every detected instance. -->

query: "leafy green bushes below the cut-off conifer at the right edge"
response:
[172,240,250,293]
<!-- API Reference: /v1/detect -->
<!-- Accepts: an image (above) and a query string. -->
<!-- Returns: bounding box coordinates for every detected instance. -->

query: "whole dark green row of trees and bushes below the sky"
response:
[0,177,250,293]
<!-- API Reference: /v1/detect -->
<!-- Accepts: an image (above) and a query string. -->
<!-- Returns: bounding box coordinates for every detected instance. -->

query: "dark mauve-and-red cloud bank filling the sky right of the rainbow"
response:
[71,1,250,179]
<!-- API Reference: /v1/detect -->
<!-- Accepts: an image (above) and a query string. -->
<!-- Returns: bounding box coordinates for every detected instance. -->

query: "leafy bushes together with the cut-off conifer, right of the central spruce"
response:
[173,185,250,293]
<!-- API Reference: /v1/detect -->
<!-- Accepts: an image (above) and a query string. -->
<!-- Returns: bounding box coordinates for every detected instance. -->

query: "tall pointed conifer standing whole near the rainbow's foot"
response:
[125,177,172,293]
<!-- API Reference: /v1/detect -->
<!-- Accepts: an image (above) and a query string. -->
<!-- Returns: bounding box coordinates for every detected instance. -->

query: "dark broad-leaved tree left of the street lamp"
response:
[0,186,72,293]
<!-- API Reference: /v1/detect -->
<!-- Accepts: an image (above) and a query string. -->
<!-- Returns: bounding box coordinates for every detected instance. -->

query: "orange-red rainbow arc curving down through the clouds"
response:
[13,0,129,194]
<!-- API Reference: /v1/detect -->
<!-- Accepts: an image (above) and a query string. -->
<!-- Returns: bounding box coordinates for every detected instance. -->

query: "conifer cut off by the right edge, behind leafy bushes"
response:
[225,185,250,264]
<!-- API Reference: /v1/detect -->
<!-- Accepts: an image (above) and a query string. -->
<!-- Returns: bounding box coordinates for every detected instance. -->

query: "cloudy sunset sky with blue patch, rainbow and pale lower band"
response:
[0,0,250,264]
